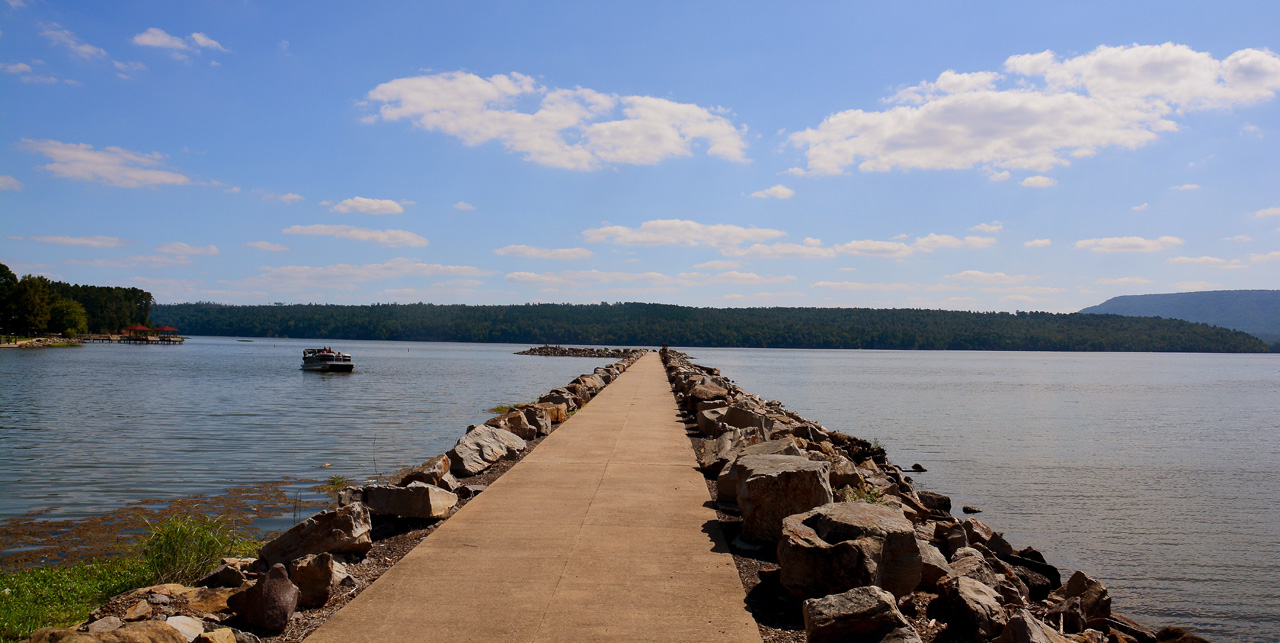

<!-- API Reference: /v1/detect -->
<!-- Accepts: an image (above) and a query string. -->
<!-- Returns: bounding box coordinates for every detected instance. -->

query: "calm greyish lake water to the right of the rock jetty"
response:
[689,348,1280,643]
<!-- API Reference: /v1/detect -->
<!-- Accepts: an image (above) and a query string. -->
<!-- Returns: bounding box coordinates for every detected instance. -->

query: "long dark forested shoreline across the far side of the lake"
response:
[152,302,1267,352]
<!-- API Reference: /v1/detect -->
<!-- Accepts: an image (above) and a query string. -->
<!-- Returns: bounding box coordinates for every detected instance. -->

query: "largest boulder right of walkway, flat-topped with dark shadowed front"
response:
[778,502,923,598]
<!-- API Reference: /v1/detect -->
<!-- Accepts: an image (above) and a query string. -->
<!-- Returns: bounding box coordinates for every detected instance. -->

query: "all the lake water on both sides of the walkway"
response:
[0,337,1280,642]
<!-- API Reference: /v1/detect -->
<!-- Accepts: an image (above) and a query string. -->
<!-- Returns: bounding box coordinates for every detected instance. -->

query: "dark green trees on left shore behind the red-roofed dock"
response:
[0,264,155,337]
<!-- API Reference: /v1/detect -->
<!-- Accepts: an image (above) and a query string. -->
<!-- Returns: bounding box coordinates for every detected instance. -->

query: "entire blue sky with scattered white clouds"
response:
[0,0,1280,313]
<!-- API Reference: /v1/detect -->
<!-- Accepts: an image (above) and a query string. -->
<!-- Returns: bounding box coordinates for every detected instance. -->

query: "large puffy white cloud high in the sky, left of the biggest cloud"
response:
[369,72,746,170]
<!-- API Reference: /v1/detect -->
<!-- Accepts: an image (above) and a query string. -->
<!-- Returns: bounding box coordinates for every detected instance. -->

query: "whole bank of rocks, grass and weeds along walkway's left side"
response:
[0,350,648,643]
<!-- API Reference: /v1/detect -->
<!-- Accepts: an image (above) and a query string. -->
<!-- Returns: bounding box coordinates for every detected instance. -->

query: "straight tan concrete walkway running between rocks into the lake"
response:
[307,354,760,643]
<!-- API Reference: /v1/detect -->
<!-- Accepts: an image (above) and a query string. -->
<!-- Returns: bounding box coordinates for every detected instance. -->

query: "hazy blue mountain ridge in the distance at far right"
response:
[1080,291,1280,343]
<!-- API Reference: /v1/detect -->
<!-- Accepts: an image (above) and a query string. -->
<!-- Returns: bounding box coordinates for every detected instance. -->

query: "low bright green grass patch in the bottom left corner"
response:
[0,558,151,643]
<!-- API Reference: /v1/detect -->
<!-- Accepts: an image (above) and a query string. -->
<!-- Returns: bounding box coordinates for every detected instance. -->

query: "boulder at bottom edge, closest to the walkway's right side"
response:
[804,587,920,643]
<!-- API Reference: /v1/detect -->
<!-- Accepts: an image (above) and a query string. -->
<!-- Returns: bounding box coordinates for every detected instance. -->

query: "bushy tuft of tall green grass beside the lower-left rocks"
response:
[141,516,257,584]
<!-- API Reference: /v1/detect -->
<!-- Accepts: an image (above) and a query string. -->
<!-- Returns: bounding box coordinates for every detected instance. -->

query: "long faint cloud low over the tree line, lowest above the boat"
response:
[232,257,494,291]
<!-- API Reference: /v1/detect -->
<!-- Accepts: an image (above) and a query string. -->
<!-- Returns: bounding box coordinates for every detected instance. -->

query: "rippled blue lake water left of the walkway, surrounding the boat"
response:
[0,337,609,528]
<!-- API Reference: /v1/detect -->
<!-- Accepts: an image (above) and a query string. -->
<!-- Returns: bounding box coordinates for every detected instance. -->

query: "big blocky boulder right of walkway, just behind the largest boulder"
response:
[733,456,834,543]
